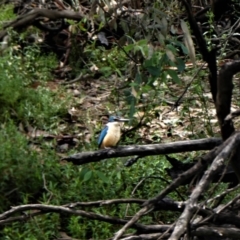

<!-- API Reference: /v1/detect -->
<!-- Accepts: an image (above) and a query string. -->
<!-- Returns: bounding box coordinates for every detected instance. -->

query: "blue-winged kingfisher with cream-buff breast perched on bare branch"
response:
[98,116,129,148]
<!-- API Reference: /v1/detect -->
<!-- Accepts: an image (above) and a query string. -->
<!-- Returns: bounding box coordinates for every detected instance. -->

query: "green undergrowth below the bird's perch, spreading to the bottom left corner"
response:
[0,134,176,240]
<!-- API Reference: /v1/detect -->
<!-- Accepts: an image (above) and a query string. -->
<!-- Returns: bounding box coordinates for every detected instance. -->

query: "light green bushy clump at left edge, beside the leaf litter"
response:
[0,43,67,129]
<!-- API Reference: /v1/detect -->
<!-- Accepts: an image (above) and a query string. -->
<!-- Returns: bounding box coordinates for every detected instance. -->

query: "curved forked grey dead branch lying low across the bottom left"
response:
[0,199,176,232]
